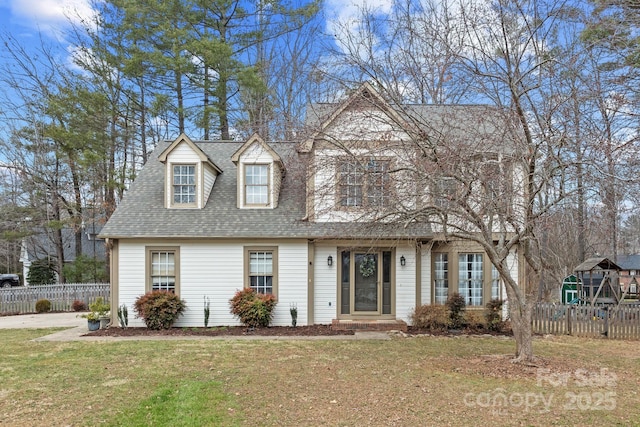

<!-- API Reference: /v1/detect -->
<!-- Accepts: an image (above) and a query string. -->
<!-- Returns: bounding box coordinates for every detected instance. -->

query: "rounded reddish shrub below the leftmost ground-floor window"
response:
[133,291,187,330]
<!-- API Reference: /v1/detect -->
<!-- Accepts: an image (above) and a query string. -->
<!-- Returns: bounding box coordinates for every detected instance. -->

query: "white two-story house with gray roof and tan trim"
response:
[101,84,521,327]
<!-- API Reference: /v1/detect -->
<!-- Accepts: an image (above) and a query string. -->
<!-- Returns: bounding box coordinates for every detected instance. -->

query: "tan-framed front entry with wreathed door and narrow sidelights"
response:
[340,249,392,317]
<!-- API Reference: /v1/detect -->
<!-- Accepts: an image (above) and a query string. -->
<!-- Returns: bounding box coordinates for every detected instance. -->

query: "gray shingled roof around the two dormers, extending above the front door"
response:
[100,141,431,239]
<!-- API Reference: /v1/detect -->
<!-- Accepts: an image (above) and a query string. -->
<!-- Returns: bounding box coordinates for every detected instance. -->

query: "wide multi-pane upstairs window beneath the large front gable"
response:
[338,159,391,207]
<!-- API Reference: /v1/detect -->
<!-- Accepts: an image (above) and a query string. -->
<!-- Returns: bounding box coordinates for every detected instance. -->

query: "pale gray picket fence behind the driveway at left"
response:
[0,283,110,314]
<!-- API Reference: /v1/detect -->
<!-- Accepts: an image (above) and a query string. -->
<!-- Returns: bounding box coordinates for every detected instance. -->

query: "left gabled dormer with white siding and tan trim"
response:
[158,134,222,209]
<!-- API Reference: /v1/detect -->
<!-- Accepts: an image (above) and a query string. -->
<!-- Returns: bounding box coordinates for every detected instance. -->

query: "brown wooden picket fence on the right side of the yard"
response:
[533,303,640,340]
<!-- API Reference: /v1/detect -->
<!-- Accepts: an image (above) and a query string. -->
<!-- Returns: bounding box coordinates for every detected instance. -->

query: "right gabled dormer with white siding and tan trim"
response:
[231,134,284,209]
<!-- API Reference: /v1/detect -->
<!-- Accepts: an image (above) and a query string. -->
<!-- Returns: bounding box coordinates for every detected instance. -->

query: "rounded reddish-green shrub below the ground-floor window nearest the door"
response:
[229,288,278,328]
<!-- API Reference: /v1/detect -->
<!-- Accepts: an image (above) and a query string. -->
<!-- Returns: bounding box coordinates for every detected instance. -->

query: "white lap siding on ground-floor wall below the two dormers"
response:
[118,240,308,327]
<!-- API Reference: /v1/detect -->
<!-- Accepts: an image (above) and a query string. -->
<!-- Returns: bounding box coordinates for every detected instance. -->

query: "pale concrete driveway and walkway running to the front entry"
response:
[0,313,391,342]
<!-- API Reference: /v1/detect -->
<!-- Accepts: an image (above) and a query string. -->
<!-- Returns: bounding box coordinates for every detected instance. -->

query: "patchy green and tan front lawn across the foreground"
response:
[0,330,640,426]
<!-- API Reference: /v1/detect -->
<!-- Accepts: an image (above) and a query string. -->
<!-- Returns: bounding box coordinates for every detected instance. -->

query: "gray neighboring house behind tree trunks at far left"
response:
[20,225,106,286]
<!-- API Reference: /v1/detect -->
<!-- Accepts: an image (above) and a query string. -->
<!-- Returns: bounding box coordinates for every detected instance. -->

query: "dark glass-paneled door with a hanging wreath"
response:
[353,253,379,312]
